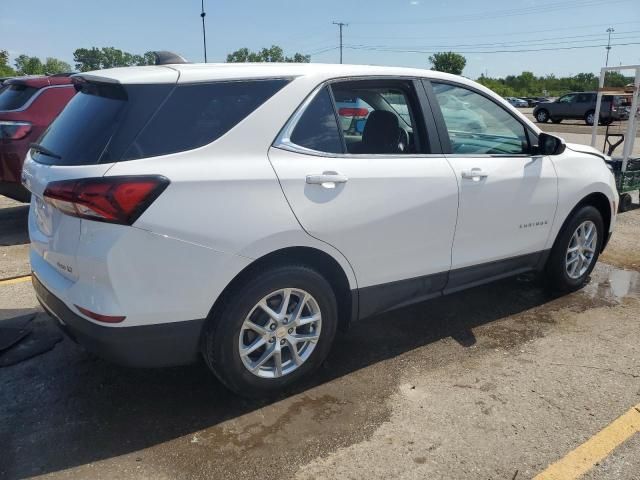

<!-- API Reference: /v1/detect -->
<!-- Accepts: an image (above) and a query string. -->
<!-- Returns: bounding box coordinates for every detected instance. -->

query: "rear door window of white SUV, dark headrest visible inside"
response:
[331,80,423,155]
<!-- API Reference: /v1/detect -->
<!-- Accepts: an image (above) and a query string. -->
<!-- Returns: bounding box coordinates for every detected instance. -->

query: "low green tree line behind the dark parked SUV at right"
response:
[478,72,633,97]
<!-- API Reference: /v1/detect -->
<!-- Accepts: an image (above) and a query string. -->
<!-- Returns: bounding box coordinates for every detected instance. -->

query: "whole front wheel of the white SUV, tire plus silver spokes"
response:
[545,205,605,292]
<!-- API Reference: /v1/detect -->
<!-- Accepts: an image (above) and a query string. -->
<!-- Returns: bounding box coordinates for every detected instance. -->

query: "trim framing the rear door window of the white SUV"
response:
[271,75,443,158]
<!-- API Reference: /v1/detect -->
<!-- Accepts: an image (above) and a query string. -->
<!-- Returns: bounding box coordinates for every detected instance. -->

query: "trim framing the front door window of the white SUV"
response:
[423,78,539,158]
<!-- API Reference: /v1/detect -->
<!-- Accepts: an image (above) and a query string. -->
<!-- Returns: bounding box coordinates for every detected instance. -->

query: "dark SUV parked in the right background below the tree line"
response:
[533,92,624,125]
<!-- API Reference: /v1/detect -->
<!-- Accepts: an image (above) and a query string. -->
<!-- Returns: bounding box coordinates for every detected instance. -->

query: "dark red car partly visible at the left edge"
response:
[0,74,76,202]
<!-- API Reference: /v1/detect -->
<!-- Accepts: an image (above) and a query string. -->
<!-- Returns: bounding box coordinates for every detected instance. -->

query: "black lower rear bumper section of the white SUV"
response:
[32,274,204,367]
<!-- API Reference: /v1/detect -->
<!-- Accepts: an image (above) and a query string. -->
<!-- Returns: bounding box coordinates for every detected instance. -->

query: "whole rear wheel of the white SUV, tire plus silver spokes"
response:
[202,265,338,398]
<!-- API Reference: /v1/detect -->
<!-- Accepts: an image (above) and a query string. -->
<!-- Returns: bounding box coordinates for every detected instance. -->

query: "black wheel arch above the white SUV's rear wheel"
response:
[208,246,358,331]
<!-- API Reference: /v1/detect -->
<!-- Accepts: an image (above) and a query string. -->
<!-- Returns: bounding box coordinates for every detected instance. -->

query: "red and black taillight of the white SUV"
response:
[44,175,169,225]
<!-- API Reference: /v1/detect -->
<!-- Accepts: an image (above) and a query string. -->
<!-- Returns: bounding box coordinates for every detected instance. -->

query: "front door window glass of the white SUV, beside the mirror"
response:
[432,82,529,155]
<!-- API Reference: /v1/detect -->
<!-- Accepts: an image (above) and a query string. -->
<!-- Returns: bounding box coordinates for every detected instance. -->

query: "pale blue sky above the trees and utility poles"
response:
[0,0,640,78]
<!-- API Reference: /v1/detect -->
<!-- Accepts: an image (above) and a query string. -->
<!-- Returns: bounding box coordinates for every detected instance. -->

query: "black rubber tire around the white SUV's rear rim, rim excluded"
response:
[202,265,338,398]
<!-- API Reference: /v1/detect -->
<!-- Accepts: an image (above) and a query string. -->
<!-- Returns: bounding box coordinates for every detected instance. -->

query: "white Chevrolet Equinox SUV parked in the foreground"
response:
[23,64,618,395]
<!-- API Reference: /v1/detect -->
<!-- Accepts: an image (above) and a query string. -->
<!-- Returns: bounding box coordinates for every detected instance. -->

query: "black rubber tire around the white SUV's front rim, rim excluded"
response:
[545,205,605,292]
